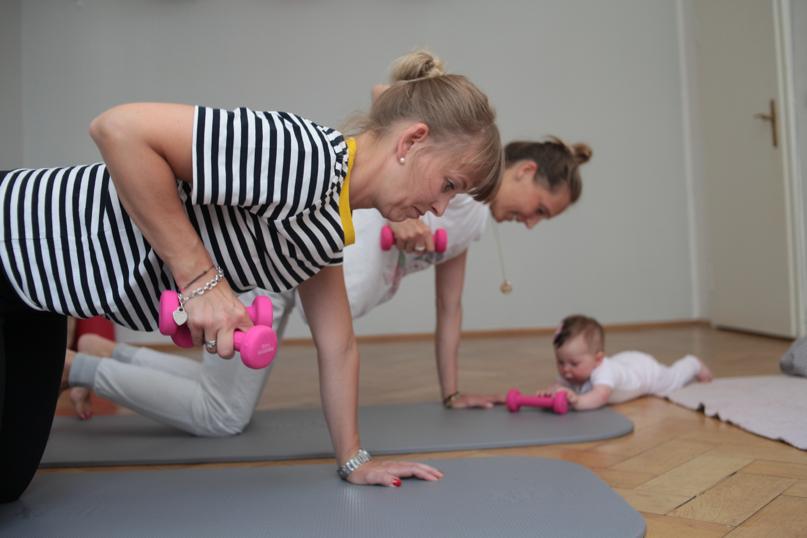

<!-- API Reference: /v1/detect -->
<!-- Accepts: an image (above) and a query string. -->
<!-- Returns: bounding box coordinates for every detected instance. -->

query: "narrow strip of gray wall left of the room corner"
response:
[0,0,22,170]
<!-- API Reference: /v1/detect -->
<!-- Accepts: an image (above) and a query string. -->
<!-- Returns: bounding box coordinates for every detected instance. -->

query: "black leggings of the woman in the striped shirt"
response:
[0,272,67,502]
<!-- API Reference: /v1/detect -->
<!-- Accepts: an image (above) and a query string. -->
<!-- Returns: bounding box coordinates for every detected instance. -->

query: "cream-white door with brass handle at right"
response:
[693,0,796,336]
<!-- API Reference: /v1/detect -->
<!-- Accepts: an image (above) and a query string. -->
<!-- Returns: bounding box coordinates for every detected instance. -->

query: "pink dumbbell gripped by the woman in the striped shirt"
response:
[160,290,277,370]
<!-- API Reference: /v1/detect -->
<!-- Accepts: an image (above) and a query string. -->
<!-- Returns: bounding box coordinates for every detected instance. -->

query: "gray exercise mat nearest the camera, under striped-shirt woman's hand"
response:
[0,457,645,538]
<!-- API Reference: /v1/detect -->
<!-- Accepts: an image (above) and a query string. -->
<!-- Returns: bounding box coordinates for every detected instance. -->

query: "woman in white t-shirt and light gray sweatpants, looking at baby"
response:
[64,138,591,436]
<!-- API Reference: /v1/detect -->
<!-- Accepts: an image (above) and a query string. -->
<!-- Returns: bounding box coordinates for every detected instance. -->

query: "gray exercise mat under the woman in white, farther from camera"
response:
[41,403,633,467]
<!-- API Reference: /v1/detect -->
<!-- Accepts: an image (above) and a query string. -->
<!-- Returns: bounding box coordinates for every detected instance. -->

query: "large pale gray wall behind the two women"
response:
[9,0,700,336]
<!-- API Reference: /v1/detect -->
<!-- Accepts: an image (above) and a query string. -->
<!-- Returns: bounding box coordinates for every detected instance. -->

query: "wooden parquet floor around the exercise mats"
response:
[52,325,807,538]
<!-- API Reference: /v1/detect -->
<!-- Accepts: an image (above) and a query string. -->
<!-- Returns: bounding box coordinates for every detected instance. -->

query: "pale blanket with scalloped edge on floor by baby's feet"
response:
[668,375,807,450]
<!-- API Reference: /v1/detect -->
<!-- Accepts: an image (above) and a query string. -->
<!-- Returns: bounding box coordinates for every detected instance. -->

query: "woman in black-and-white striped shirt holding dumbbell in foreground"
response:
[0,53,502,502]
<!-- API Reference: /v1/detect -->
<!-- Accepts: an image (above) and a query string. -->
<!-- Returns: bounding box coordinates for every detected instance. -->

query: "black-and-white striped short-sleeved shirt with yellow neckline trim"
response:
[0,107,353,330]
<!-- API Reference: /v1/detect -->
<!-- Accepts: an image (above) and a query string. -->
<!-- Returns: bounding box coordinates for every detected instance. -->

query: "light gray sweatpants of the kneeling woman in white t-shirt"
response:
[70,292,295,437]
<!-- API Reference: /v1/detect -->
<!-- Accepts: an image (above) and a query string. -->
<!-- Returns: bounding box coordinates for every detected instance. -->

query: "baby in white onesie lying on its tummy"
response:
[542,315,712,410]
